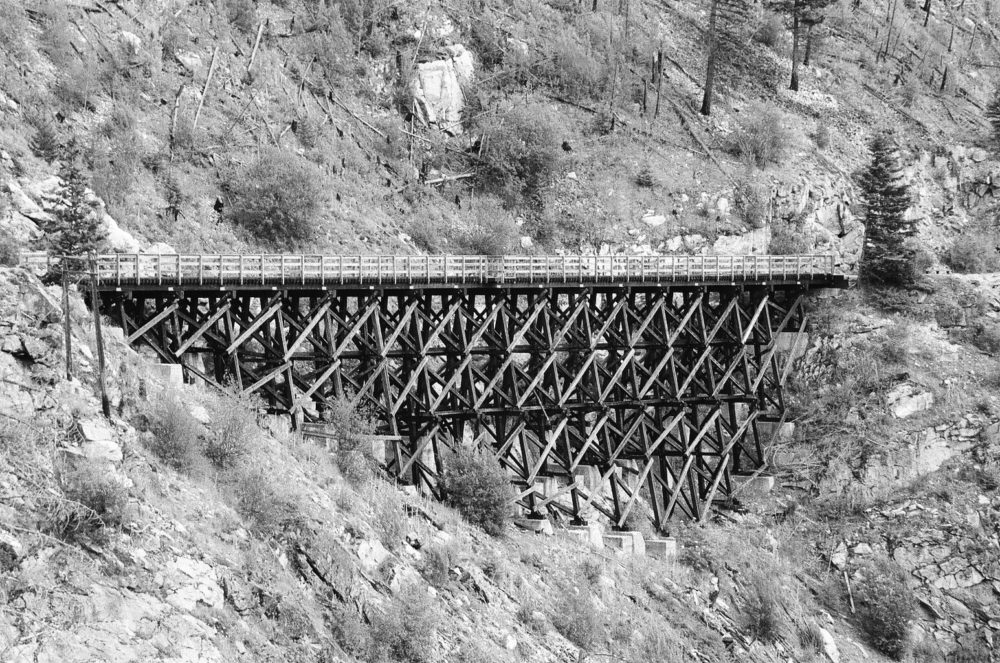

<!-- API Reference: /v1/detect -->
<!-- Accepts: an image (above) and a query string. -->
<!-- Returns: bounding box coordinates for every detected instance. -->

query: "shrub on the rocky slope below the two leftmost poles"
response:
[43,461,129,538]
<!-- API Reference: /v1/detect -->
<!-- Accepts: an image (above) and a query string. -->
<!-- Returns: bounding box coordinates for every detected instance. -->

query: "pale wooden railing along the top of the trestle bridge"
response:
[22,253,838,286]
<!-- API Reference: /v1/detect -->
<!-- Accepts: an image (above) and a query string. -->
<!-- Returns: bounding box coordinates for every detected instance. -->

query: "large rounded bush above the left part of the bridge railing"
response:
[225,148,327,246]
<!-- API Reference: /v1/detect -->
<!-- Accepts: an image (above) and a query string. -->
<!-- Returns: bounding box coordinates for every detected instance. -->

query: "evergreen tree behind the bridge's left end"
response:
[51,148,107,257]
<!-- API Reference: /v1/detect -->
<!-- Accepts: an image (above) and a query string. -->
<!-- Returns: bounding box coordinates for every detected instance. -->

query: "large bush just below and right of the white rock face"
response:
[478,106,560,207]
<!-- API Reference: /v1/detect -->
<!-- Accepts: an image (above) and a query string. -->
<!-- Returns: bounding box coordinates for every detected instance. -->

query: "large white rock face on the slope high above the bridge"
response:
[411,44,475,135]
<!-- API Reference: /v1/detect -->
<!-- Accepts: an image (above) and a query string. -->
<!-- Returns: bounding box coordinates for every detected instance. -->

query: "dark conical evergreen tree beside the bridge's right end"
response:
[859,134,916,285]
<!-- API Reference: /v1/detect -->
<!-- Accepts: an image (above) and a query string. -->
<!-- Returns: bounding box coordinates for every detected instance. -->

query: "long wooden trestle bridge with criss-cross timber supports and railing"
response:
[27,254,848,529]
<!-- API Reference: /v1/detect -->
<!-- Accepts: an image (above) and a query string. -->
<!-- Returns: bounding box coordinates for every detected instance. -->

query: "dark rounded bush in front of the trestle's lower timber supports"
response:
[441,447,514,536]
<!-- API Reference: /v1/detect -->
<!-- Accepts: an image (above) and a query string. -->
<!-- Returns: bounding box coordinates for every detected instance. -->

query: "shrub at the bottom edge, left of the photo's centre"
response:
[368,587,440,663]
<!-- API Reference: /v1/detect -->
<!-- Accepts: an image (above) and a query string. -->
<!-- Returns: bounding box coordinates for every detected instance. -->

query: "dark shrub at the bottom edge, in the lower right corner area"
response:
[855,558,914,660]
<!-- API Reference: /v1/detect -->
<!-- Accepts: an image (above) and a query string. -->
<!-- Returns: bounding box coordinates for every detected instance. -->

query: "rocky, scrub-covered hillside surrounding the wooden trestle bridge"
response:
[0,0,1000,663]
